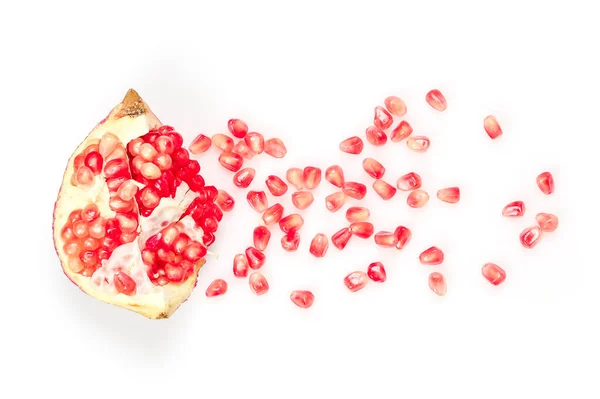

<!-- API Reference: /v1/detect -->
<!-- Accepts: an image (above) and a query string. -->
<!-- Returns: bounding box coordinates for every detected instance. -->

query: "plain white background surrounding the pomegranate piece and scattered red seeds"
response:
[0,1,600,398]
